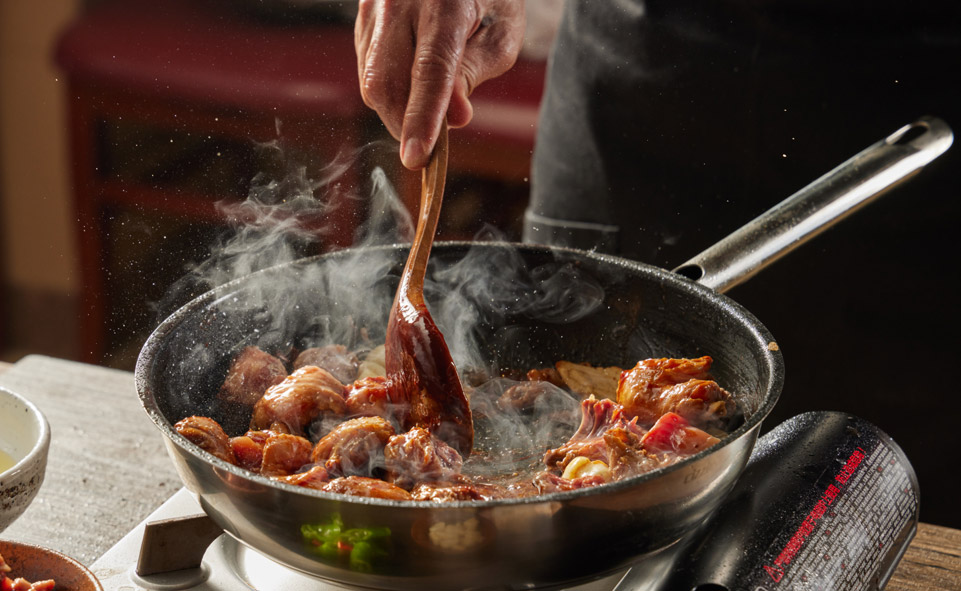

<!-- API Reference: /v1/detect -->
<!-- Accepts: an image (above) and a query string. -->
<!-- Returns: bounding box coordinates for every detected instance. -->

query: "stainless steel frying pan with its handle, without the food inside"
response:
[136,118,952,589]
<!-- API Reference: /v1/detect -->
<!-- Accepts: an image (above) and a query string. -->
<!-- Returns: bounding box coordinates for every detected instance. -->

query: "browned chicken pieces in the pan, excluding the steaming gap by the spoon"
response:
[175,352,737,502]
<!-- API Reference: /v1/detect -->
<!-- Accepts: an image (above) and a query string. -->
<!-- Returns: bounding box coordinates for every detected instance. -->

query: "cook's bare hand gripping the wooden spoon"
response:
[354,0,524,170]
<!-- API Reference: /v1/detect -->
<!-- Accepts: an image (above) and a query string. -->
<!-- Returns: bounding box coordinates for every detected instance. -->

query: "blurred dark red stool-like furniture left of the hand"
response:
[55,0,367,363]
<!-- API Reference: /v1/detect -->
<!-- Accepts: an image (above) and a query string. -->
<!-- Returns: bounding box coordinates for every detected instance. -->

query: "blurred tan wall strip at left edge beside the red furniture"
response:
[0,0,82,366]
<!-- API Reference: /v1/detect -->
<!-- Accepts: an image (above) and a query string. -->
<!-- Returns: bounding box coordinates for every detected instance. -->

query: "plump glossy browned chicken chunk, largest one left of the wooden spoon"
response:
[250,365,347,435]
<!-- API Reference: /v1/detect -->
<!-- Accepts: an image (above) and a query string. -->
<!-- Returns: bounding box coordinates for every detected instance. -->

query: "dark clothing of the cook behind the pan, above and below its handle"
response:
[525,0,961,527]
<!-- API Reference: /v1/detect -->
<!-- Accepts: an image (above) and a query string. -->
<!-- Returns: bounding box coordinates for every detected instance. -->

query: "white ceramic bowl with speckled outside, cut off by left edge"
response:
[0,388,50,532]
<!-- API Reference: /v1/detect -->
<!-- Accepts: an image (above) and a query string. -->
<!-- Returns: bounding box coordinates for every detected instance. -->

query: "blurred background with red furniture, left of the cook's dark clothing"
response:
[0,0,560,369]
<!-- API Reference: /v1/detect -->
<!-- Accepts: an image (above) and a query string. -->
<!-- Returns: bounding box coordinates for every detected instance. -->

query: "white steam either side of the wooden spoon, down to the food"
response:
[157,130,604,470]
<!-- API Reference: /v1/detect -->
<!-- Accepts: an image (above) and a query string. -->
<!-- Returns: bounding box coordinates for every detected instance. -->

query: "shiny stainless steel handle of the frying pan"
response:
[674,117,954,292]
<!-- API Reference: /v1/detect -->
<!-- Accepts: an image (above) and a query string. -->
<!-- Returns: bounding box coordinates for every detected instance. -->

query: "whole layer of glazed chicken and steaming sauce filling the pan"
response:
[175,346,740,502]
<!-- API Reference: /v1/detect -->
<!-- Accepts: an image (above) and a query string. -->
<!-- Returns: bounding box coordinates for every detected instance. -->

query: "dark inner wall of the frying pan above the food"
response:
[139,243,780,458]
